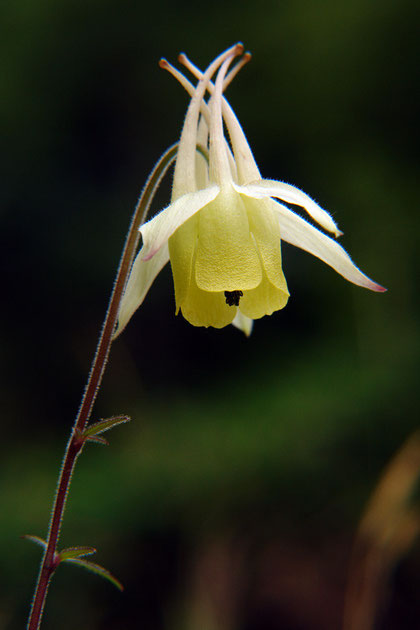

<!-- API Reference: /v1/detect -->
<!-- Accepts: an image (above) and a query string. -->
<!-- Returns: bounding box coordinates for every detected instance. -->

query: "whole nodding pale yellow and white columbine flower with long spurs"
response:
[117,44,385,334]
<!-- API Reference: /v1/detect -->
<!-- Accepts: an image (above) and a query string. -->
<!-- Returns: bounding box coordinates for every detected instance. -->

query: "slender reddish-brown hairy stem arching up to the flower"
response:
[27,144,178,630]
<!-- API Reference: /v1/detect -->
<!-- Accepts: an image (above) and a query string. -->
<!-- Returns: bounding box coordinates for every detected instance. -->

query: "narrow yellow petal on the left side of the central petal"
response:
[168,214,198,313]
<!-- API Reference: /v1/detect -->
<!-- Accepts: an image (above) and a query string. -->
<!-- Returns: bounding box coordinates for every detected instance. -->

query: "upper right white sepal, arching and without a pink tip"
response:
[235,179,342,237]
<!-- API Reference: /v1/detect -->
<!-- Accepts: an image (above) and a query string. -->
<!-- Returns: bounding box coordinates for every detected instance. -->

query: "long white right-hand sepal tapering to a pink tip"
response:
[272,202,386,292]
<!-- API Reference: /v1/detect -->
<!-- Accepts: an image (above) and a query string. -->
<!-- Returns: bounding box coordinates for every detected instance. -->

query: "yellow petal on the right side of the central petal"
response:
[243,197,288,294]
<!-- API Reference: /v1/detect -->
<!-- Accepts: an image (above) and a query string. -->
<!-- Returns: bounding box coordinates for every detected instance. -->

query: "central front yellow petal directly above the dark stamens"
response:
[195,187,262,291]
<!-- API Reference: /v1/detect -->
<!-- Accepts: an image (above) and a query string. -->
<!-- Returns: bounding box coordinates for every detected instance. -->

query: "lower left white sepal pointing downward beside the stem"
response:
[114,244,169,339]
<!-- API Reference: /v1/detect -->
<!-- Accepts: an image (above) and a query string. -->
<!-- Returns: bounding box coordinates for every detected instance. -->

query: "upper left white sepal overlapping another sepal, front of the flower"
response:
[140,185,219,260]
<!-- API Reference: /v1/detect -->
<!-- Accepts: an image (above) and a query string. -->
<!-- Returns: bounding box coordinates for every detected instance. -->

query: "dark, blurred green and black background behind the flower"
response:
[0,0,420,630]
